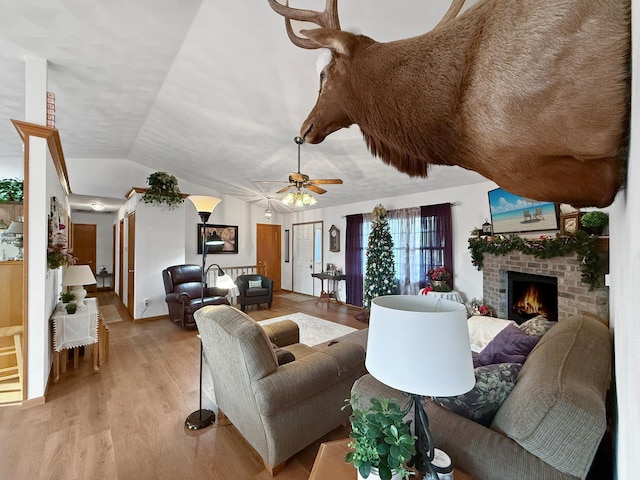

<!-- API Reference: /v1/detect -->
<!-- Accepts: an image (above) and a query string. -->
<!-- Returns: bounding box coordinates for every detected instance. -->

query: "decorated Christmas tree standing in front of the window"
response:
[362,205,398,310]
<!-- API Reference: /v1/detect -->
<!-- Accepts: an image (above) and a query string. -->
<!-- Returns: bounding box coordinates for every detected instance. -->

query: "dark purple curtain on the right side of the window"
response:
[420,203,454,288]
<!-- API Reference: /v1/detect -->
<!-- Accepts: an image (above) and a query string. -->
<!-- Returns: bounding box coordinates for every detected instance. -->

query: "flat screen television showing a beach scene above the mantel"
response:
[489,188,560,234]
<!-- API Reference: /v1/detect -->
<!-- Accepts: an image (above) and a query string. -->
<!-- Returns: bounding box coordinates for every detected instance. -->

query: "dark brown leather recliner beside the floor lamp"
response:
[162,265,229,329]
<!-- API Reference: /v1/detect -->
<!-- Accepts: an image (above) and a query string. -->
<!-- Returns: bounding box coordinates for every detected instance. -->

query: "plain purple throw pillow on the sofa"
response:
[473,325,540,367]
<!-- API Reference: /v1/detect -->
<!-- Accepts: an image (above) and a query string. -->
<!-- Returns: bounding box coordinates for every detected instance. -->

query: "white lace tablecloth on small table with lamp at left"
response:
[51,298,99,352]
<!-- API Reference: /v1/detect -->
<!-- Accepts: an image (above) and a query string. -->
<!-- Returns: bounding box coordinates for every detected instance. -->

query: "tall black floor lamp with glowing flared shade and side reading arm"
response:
[184,195,224,430]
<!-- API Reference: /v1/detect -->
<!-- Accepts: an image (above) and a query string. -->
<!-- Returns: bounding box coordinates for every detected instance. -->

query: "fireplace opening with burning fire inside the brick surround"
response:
[507,271,558,324]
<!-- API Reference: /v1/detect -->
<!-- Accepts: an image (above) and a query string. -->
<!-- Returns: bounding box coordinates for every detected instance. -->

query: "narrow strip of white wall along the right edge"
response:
[609,0,640,474]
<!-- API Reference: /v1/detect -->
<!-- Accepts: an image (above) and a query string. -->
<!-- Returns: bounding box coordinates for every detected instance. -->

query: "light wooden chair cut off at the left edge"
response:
[0,325,23,402]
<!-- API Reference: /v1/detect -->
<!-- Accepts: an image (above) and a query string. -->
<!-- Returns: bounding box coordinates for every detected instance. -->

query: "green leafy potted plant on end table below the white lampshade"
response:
[344,395,416,480]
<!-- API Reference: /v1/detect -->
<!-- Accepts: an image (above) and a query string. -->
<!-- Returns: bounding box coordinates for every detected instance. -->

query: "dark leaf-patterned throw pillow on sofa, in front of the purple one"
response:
[432,363,522,427]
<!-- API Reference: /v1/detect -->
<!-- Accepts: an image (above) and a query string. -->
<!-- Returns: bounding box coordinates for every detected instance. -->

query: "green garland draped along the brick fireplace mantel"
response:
[469,230,604,291]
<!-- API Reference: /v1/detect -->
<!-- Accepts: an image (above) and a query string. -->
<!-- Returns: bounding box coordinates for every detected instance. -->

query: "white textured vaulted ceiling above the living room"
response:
[0,0,484,212]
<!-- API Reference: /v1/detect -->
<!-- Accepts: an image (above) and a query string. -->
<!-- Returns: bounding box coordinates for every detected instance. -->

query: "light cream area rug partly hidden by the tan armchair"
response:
[202,312,357,412]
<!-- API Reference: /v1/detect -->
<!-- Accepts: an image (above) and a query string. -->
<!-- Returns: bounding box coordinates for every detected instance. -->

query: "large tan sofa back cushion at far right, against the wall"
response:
[491,315,611,478]
